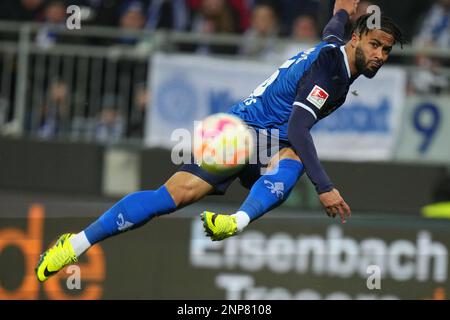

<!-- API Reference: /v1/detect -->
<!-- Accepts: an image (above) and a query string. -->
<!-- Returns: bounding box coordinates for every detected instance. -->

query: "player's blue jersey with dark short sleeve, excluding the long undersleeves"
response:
[229,37,353,141]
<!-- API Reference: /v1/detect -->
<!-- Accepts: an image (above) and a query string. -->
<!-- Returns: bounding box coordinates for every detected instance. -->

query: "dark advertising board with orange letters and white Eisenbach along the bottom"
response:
[0,198,450,299]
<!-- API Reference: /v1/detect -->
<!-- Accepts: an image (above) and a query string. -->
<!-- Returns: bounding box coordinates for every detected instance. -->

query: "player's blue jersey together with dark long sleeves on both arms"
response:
[229,9,357,194]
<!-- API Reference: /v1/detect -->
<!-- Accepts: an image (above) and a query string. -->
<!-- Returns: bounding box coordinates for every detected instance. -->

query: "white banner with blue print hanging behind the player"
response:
[146,54,406,161]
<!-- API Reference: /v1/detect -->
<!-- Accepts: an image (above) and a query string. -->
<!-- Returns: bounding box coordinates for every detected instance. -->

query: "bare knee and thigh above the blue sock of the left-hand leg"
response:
[164,171,214,208]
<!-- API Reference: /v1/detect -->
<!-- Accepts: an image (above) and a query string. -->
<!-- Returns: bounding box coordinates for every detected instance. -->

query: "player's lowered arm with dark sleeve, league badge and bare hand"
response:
[288,54,350,222]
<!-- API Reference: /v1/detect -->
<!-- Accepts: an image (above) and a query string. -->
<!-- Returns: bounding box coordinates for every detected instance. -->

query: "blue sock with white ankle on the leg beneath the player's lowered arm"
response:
[236,159,304,231]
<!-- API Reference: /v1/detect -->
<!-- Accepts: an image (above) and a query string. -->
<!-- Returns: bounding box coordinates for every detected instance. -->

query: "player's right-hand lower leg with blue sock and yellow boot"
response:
[201,151,303,241]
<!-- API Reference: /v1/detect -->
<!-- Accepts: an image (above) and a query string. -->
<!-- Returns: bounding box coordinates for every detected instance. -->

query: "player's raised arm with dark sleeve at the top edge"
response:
[322,0,359,43]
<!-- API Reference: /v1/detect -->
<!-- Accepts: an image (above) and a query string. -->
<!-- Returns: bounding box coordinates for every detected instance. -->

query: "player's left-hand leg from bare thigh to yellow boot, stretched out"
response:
[35,172,212,281]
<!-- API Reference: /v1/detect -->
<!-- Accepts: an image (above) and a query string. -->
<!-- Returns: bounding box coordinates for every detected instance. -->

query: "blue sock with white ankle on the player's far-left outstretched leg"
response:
[70,186,176,256]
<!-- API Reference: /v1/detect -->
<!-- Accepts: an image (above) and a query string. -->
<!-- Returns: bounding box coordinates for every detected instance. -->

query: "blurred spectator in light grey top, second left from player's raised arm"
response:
[240,5,278,57]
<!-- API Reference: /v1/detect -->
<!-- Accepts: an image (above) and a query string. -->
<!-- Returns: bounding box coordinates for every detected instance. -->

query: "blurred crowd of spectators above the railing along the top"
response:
[0,0,450,55]
